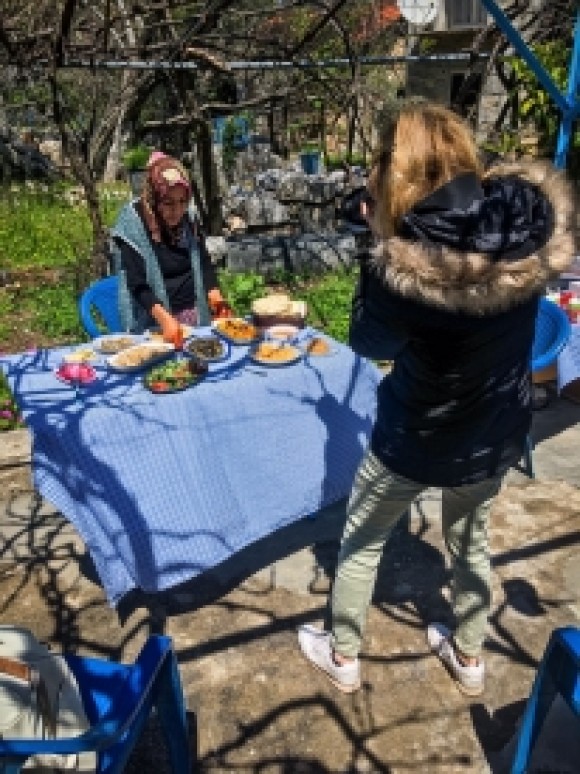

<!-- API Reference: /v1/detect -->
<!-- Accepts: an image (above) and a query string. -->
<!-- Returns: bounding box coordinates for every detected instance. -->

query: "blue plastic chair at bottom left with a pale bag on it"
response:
[0,635,192,774]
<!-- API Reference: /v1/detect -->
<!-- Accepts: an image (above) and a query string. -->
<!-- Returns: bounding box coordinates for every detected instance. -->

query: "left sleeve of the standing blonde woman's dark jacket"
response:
[349,260,407,360]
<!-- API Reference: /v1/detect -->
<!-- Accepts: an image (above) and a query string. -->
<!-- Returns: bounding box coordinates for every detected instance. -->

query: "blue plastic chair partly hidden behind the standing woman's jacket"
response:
[524,298,572,478]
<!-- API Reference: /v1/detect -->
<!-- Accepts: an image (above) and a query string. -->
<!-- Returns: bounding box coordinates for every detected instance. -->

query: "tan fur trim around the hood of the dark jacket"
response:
[373,162,576,315]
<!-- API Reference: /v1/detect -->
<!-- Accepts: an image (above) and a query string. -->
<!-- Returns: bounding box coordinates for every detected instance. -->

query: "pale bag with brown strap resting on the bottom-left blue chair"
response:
[0,626,96,774]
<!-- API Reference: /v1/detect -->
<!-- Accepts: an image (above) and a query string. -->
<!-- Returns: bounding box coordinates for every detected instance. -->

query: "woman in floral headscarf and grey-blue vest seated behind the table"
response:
[111,152,228,344]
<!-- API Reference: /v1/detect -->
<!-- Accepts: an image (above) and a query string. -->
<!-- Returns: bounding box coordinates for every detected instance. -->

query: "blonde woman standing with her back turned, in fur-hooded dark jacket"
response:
[299,103,576,696]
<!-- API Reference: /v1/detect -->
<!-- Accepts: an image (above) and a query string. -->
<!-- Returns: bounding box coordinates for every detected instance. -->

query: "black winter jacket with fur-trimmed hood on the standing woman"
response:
[350,163,575,486]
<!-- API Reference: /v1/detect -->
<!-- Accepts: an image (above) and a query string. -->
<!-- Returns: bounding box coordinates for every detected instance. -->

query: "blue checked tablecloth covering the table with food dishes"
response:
[0,331,381,604]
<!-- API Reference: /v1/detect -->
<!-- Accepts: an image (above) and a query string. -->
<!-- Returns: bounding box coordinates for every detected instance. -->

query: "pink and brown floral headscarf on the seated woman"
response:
[141,151,191,242]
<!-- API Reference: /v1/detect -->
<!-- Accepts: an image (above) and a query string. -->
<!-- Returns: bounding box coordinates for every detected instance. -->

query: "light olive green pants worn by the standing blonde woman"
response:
[331,450,502,657]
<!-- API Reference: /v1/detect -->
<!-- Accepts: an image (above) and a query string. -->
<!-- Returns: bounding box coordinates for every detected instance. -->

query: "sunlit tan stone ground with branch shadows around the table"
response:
[0,398,580,774]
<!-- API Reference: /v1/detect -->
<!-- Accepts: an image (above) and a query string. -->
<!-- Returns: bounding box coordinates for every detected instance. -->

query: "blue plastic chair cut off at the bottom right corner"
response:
[511,627,580,774]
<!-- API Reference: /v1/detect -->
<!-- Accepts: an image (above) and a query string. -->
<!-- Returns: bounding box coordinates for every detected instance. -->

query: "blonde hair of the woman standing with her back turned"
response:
[370,103,483,237]
